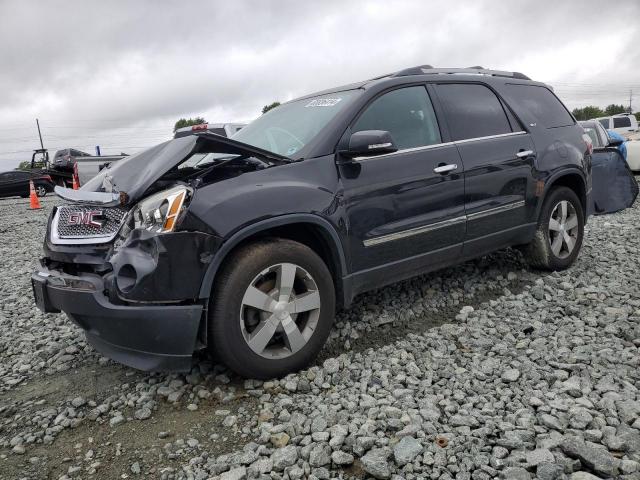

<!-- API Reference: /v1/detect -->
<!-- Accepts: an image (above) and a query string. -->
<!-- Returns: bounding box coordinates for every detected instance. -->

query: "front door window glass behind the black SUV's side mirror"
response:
[351,86,441,150]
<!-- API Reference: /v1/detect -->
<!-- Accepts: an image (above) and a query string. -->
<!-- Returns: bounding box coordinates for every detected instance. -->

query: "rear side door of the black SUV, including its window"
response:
[435,83,535,256]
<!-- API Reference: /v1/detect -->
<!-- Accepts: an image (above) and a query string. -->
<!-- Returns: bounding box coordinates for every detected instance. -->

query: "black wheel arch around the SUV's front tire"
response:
[200,214,351,306]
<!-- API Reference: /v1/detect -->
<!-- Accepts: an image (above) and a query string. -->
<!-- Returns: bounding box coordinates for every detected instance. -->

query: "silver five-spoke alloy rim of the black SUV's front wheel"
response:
[240,263,320,359]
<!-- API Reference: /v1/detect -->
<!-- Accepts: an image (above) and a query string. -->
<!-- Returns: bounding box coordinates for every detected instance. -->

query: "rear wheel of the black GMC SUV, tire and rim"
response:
[524,187,584,270]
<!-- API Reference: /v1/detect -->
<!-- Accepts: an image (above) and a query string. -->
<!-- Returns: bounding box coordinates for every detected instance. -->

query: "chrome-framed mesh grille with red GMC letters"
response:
[53,205,127,241]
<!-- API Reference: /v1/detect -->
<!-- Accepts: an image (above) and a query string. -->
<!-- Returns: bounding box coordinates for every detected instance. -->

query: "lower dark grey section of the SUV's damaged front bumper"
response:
[31,267,203,371]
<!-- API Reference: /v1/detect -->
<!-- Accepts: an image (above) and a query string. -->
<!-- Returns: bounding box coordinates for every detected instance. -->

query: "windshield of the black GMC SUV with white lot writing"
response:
[232,90,358,157]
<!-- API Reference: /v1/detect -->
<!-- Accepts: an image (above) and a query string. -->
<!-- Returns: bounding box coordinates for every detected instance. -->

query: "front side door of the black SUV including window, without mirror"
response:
[340,85,465,293]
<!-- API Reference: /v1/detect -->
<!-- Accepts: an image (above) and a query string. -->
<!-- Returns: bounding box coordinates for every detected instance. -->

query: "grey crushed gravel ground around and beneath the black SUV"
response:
[0,185,640,480]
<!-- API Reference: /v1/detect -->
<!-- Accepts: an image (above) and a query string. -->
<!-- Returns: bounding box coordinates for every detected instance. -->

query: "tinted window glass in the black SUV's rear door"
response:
[437,83,510,140]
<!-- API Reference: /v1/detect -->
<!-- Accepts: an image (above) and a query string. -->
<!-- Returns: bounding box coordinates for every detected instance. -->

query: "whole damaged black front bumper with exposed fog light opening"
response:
[31,231,218,371]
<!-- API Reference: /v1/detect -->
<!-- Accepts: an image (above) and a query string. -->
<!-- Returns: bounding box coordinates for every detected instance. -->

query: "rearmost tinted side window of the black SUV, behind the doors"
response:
[505,84,574,128]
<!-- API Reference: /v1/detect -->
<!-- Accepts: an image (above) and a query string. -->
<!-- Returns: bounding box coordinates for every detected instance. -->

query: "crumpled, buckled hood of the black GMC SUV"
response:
[63,132,292,204]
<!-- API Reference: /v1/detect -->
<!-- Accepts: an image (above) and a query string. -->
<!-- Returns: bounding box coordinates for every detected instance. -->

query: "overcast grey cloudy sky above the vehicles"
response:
[0,0,640,170]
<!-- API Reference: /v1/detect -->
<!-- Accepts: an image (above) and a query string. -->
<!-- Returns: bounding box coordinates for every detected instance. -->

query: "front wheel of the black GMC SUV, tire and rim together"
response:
[208,239,335,379]
